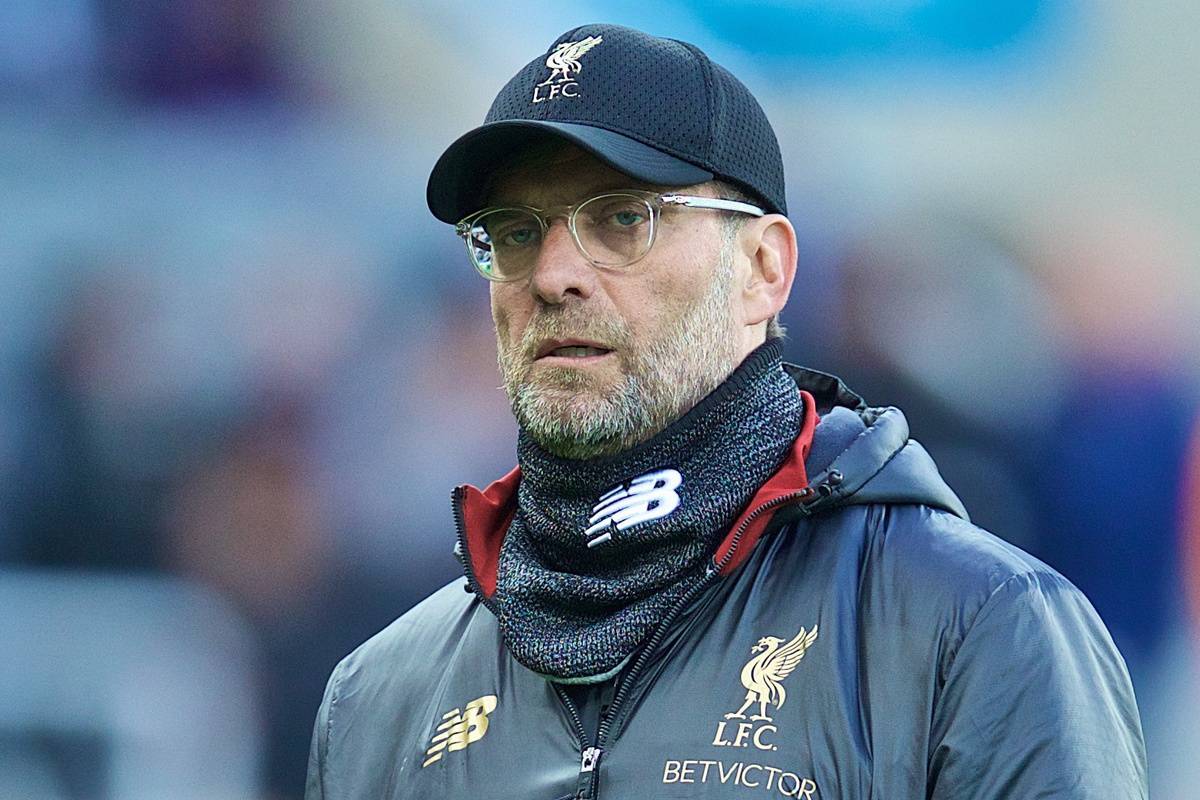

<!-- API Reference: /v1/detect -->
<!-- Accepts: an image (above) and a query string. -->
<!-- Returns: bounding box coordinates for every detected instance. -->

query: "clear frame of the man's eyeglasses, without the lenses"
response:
[455,190,766,282]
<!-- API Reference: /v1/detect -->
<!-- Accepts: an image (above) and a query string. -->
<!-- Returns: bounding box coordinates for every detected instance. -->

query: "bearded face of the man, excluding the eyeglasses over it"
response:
[488,148,744,458]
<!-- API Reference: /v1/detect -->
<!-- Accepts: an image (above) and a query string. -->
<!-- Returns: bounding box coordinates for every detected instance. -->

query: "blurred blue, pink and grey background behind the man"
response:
[0,0,1200,800]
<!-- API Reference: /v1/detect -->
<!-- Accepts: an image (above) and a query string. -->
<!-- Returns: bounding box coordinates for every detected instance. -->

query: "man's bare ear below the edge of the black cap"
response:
[738,213,797,326]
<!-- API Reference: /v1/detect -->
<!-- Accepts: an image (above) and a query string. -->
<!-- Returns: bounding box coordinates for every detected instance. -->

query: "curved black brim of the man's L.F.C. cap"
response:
[425,120,713,223]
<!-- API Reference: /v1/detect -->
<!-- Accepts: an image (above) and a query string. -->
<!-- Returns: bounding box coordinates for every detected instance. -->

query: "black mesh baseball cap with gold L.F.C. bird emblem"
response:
[426,24,787,223]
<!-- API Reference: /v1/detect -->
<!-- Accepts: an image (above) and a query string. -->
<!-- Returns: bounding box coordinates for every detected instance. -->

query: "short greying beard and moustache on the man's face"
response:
[497,249,737,459]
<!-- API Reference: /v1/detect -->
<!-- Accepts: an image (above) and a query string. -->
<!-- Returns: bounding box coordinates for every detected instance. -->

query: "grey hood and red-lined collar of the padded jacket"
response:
[454,365,968,599]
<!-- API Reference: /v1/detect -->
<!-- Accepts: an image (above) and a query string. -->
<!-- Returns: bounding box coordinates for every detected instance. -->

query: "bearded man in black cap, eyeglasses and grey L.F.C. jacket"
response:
[307,25,1146,800]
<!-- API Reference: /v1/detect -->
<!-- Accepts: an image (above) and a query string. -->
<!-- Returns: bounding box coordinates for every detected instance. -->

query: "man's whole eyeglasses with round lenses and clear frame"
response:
[455,190,766,281]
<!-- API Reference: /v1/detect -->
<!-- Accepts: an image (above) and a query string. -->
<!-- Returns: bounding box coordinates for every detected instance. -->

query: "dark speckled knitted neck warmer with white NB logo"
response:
[494,341,802,682]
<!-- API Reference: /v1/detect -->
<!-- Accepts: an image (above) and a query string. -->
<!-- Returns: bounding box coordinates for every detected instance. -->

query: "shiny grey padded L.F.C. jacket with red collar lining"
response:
[306,367,1147,800]
